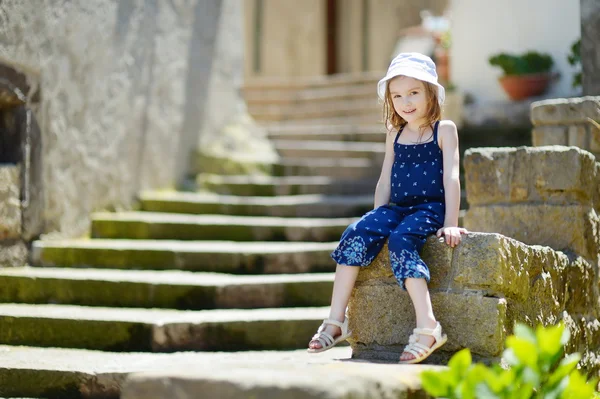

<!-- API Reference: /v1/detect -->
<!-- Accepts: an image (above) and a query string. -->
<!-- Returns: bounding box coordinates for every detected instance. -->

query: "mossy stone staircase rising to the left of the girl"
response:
[0,76,432,398]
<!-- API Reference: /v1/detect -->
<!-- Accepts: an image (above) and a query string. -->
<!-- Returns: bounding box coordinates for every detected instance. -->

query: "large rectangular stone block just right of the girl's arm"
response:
[464,146,598,206]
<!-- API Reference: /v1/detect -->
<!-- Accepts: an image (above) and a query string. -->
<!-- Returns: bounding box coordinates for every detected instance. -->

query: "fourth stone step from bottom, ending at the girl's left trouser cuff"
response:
[31,239,337,274]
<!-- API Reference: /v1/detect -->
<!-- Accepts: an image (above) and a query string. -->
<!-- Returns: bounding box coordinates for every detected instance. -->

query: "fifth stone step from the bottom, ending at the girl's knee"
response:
[92,212,355,242]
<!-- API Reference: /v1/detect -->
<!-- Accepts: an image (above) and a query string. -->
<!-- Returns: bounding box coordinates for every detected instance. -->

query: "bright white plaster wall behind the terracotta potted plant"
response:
[450,0,581,103]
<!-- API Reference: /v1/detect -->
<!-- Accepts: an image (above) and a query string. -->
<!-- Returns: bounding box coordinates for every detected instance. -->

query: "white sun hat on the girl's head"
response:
[377,53,446,105]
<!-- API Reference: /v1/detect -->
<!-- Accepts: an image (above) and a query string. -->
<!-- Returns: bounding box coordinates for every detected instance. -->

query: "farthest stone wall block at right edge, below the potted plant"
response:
[531,96,600,158]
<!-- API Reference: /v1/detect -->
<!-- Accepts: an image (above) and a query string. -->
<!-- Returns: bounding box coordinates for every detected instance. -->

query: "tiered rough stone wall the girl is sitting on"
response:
[348,146,600,375]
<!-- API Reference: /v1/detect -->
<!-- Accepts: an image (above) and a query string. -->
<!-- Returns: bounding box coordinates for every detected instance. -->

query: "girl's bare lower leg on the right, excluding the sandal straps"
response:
[400,278,437,361]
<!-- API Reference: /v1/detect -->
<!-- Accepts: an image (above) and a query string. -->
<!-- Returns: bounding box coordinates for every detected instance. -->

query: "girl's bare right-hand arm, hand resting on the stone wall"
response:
[437,121,467,247]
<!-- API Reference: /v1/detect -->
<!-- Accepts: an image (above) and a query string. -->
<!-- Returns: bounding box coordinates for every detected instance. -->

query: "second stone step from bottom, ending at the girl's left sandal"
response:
[0,303,329,352]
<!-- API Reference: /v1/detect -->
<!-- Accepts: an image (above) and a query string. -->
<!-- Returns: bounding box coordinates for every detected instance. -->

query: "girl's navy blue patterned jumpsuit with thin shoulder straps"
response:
[331,121,445,289]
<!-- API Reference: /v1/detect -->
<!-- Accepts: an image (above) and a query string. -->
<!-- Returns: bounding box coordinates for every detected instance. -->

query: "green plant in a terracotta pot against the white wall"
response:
[489,51,554,100]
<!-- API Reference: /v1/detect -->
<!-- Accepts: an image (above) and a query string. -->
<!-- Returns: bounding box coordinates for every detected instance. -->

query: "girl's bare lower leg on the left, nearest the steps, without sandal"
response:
[308,265,360,349]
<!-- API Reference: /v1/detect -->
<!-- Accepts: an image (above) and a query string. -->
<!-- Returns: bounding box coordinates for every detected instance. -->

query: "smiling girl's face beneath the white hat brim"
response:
[389,76,427,123]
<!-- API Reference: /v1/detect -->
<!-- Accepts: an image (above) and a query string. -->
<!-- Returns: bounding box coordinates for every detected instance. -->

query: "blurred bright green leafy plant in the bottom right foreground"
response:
[421,324,600,399]
